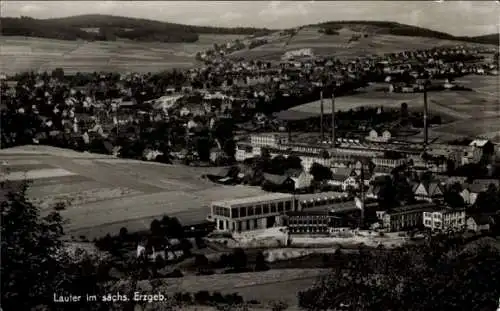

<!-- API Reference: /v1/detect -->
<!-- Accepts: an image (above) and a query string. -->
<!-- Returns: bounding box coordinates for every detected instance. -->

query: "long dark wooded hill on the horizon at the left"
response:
[0,14,270,42]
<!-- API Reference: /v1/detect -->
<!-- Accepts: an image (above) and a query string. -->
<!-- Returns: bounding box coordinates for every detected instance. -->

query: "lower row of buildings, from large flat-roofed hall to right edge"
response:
[210,188,498,235]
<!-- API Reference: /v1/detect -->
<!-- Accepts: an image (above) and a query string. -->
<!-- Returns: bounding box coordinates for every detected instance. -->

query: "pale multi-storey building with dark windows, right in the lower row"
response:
[423,207,466,231]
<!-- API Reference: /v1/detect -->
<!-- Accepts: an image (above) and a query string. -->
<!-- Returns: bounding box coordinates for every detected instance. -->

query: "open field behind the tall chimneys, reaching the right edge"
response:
[287,75,500,141]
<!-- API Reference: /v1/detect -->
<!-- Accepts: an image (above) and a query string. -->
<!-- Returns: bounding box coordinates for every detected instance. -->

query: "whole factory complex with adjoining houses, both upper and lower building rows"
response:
[205,134,500,234]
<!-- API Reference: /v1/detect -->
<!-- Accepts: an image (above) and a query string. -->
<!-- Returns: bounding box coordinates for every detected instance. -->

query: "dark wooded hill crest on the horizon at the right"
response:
[314,21,499,45]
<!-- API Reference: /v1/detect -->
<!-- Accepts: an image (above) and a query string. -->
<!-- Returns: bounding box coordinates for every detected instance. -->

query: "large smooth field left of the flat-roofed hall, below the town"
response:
[0,146,270,238]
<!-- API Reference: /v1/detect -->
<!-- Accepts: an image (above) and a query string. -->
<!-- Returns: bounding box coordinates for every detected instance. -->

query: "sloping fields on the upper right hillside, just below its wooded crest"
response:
[232,27,492,60]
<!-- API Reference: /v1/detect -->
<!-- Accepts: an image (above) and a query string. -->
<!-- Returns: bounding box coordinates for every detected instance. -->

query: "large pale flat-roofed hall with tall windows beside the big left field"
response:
[210,193,296,232]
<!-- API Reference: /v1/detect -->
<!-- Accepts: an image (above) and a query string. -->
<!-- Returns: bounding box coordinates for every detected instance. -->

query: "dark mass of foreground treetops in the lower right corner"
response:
[299,239,500,311]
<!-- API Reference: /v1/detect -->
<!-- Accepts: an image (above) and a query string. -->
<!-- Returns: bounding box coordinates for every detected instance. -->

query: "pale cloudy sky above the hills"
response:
[0,0,500,36]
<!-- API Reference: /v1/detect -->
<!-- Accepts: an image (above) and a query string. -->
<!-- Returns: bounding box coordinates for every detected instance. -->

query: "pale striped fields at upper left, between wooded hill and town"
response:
[0,35,243,74]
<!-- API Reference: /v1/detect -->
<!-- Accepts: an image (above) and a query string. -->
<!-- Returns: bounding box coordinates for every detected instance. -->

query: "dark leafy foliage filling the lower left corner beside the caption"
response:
[0,181,115,310]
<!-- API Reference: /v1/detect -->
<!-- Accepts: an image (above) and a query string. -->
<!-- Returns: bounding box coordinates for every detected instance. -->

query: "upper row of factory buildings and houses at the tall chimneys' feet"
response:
[223,132,495,195]
